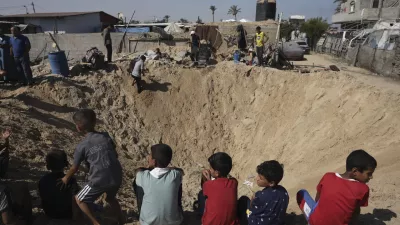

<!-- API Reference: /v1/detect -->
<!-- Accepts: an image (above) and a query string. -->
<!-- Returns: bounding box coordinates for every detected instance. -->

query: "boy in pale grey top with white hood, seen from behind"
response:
[134,144,183,225]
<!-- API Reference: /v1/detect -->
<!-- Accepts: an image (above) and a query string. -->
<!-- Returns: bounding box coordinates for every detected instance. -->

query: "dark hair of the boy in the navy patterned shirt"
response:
[257,160,283,184]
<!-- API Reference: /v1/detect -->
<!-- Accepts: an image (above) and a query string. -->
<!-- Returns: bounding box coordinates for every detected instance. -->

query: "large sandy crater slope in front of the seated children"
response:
[0,62,400,224]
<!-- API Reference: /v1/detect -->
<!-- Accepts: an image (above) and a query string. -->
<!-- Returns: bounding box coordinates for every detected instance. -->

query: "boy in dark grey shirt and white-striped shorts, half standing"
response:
[61,109,124,225]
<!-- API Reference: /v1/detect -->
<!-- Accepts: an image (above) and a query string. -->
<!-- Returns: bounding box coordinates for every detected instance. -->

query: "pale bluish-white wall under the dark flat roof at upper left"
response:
[24,13,101,33]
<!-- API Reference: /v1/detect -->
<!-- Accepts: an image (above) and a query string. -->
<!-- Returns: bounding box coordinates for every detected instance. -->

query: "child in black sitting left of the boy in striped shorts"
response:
[39,150,79,220]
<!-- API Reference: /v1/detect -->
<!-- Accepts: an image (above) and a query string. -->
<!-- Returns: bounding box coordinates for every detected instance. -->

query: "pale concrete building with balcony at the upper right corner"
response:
[332,0,400,30]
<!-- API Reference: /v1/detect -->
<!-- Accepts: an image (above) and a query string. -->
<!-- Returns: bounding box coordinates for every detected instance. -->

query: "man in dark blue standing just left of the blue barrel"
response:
[10,26,34,85]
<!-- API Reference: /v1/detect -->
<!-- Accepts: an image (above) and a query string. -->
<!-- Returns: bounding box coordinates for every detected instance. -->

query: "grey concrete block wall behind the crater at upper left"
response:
[26,33,187,61]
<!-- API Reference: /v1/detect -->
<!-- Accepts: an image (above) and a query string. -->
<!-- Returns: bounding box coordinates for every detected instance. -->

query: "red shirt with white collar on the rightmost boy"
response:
[309,173,369,225]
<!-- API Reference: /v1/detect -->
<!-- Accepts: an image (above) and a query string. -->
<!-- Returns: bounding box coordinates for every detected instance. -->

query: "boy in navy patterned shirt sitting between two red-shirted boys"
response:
[242,160,289,225]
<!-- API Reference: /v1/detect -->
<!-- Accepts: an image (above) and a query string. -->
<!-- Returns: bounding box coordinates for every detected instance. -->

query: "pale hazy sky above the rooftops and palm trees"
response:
[0,0,335,22]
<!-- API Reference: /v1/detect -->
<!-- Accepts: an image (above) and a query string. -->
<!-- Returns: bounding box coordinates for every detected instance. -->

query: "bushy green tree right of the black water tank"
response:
[300,17,329,49]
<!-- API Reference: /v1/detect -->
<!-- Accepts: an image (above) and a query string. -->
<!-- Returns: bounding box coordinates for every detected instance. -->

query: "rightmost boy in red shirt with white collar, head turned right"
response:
[297,150,377,225]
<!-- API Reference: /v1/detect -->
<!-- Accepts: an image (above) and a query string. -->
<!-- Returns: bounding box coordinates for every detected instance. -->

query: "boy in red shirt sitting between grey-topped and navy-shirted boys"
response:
[202,152,238,225]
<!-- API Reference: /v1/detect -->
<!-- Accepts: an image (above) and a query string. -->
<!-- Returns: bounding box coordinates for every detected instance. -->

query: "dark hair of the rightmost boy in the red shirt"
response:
[346,149,377,173]
